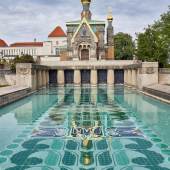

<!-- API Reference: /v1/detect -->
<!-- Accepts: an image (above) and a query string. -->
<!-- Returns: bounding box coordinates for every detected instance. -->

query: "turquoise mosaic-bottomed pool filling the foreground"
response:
[0,85,170,170]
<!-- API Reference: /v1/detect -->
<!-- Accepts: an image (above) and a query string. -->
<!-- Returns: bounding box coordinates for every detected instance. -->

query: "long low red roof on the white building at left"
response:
[10,42,43,47]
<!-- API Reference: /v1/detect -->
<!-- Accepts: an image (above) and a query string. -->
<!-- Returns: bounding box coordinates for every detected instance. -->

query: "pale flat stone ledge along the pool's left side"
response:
[0,86,30,96]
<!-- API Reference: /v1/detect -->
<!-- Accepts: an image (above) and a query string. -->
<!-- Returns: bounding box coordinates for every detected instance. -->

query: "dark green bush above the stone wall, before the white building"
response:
[10,55,35,70]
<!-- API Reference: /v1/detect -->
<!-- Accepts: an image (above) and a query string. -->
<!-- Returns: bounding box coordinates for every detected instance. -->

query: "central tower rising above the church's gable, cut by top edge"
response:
[81,0,92,20]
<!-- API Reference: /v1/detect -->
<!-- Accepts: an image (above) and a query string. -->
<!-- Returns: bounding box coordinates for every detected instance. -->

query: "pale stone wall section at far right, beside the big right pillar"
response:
[159,68,170,85]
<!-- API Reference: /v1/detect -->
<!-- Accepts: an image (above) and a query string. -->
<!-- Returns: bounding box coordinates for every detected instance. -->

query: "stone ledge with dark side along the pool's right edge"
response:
[143,84,170,101]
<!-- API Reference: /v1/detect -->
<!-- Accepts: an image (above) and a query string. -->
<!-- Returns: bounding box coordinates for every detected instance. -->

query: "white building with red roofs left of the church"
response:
[0,26,67,60]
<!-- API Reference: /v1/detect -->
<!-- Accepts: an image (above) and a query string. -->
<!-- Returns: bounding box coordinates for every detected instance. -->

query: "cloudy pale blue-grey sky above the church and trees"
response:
[0,0,170,44]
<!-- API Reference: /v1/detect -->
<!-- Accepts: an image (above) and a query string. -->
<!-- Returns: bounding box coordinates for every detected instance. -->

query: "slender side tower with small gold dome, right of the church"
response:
[107,9,114,60]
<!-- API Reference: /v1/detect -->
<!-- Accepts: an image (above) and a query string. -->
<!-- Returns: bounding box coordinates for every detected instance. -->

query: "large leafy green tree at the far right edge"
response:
[137,8,170,67]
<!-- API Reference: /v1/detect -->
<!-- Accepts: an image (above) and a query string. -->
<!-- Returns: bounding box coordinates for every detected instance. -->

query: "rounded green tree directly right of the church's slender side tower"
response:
[114,32,135,60]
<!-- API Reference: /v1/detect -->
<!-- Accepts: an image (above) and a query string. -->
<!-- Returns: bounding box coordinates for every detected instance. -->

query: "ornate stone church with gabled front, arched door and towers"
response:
[66,0,114,60]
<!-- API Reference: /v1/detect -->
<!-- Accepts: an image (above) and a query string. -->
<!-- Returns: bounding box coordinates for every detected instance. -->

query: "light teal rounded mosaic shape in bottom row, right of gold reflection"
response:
[115,151,129,166]
